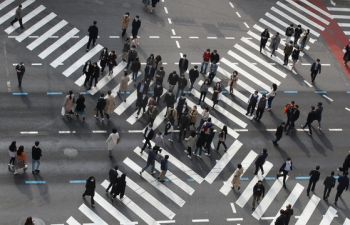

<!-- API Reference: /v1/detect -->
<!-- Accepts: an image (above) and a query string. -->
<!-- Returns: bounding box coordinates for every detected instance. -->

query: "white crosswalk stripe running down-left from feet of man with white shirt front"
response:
[252,176,288,220]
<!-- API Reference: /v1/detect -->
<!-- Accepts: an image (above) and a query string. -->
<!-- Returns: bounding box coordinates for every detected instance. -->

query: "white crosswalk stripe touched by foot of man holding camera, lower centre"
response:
[123,157,185,207]
